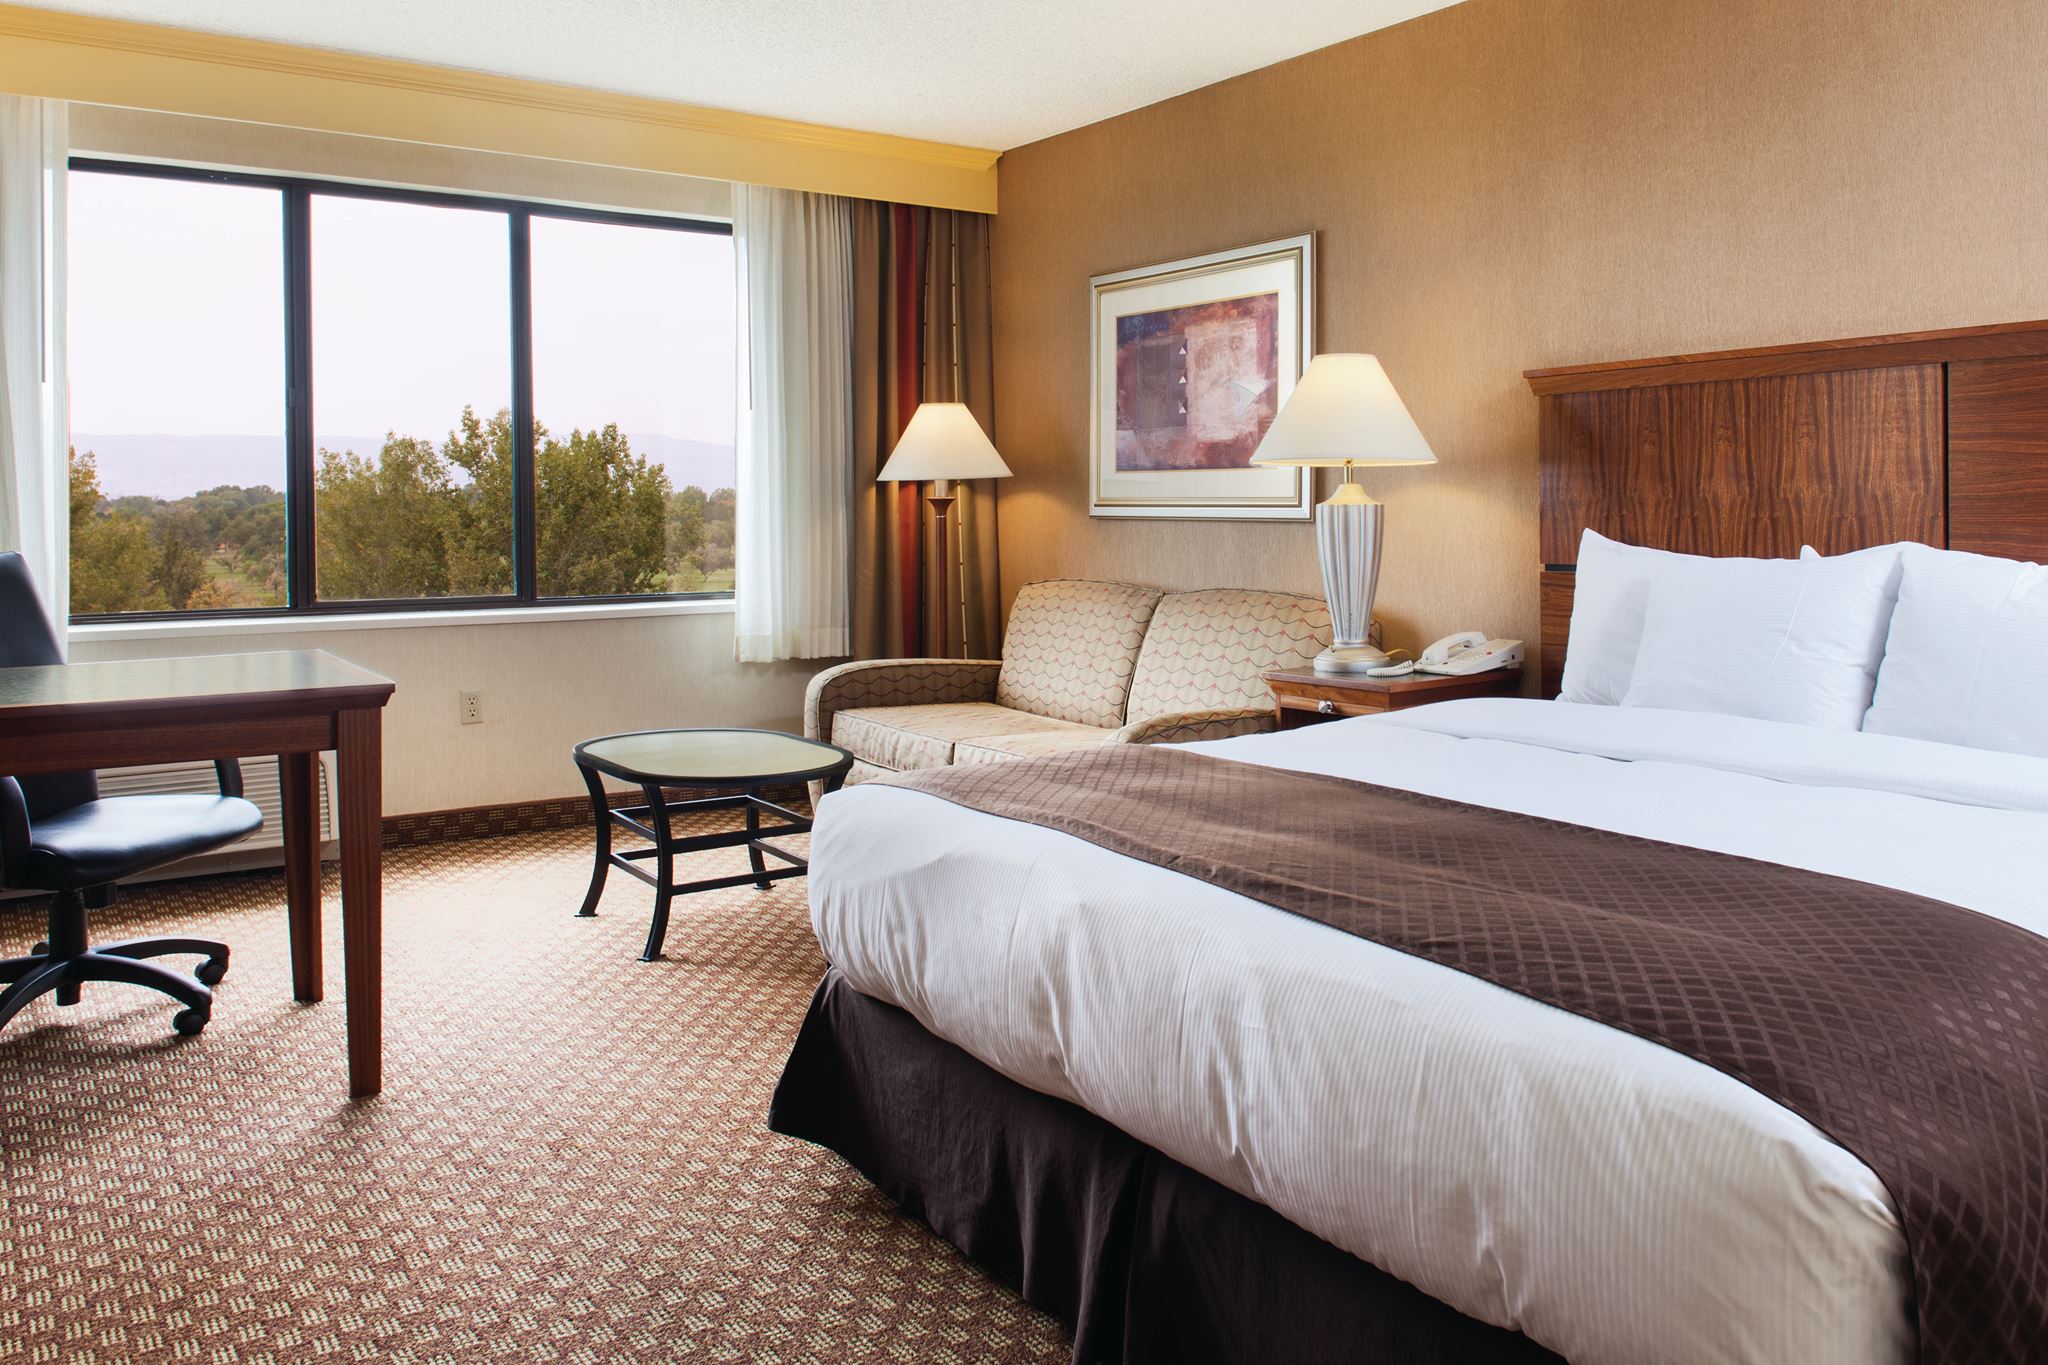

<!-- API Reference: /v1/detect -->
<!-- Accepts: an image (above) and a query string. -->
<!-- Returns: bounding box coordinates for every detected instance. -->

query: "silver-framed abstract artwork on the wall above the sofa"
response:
[1087,233,1315,522]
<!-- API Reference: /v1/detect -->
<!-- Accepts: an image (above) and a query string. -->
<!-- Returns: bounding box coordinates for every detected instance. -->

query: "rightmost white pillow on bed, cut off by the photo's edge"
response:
[1864,544,2048,757]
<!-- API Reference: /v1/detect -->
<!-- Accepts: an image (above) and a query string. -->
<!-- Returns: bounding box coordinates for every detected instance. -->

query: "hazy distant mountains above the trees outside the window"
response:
[72,432,733,499]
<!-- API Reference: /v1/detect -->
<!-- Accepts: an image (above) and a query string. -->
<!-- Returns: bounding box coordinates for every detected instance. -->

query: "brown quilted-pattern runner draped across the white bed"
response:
[887,745,2048,1365]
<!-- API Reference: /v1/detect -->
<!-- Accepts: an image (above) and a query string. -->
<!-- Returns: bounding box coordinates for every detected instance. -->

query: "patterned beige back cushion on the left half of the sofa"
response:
[995,579,1159,729]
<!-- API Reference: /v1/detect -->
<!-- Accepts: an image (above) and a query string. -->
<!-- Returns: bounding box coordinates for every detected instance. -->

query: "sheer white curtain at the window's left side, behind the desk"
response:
[0,94,72,643]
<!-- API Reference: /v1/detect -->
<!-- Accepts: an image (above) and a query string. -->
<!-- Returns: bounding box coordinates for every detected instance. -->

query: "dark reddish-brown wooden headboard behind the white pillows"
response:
[1526,321,2048,696]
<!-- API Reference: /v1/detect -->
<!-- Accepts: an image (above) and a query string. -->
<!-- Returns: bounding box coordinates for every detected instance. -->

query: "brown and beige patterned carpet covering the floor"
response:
[0,831,1069,1365]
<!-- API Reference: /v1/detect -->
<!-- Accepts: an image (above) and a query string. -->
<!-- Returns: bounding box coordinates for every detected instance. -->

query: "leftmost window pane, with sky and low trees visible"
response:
[66,167,287,616]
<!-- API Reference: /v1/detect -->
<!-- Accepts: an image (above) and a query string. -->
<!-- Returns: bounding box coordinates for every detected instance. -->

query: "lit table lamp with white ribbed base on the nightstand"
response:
[1251,354,1436,673]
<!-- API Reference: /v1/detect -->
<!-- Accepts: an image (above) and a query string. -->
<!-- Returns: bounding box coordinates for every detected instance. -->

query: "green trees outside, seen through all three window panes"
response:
[72,407,733,614]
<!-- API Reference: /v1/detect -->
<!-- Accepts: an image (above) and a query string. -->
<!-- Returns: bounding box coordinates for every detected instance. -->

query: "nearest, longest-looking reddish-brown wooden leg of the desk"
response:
[334,706,383,1099]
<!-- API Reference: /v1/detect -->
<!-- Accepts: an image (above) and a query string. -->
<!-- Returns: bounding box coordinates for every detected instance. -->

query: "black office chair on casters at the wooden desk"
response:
[0,553,262,1036]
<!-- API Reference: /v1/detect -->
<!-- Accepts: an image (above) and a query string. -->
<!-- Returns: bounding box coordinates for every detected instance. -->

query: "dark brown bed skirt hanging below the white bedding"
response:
[768,970,1561,1365]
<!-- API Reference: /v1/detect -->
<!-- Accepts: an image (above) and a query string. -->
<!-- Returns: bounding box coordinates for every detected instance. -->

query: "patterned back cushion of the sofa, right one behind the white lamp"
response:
[1126,587,1329,720]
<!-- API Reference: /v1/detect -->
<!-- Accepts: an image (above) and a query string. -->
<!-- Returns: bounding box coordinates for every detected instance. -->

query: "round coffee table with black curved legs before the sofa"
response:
[575,731,854,962]
